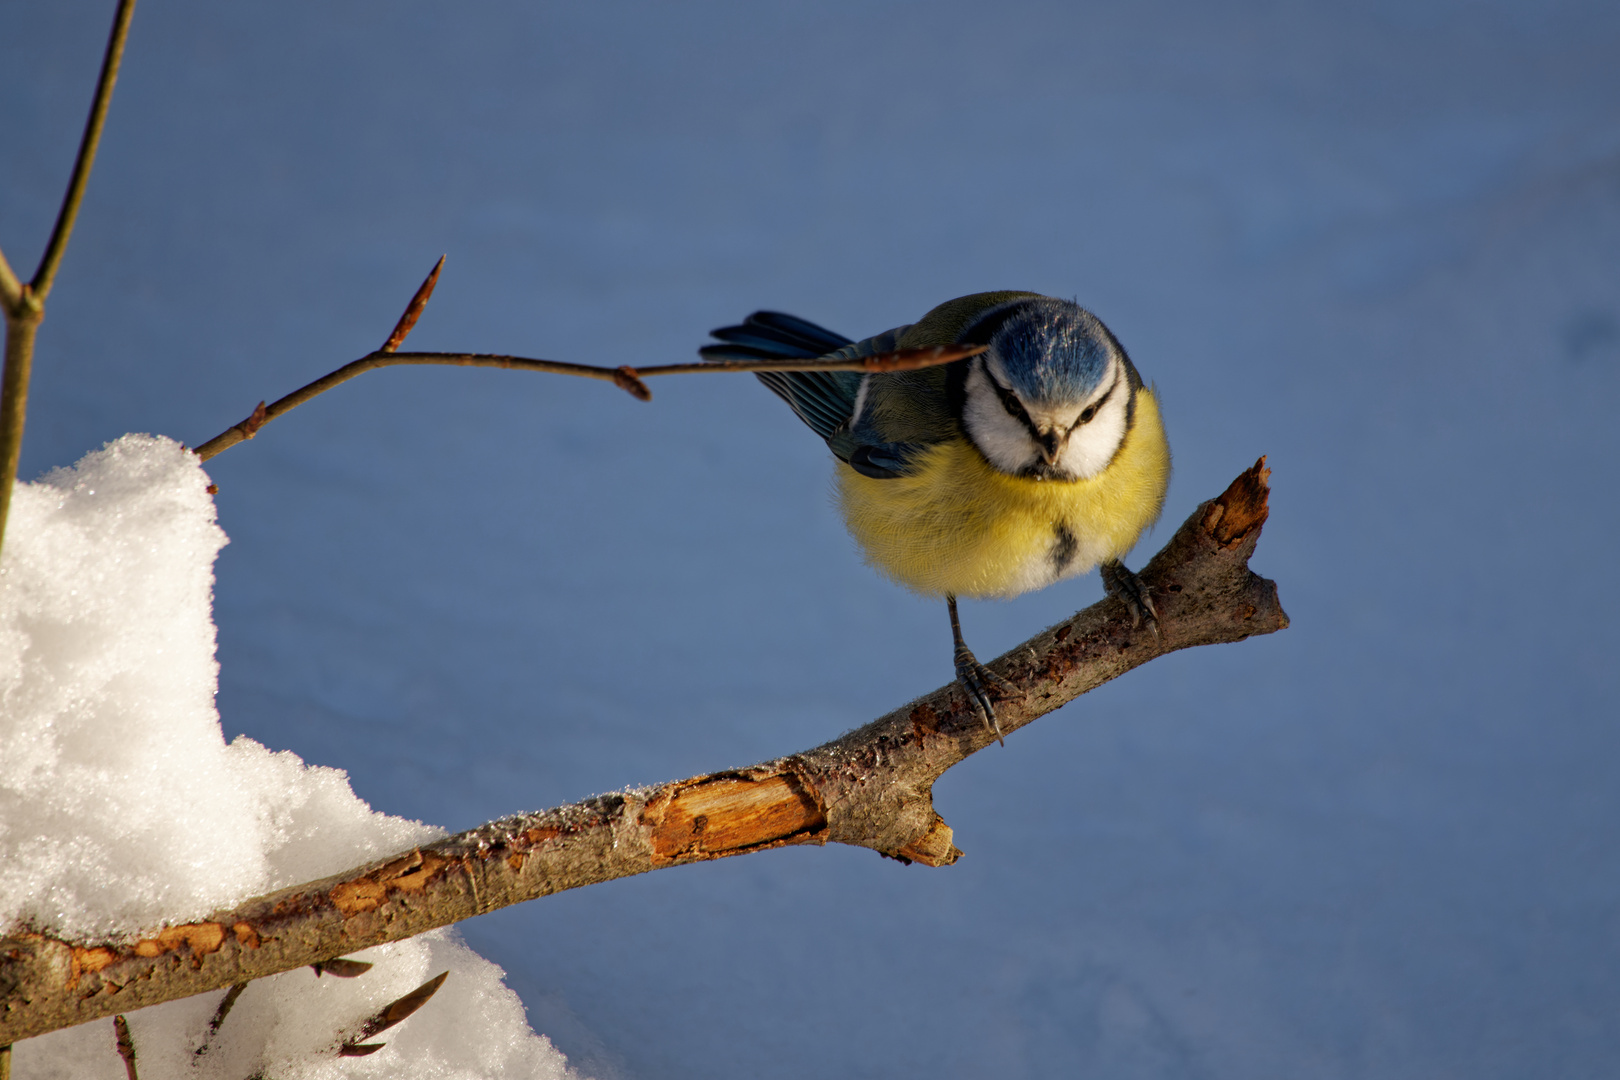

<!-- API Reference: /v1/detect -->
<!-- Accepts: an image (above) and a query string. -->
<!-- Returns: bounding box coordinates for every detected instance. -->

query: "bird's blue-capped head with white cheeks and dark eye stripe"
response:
[961,296,1140,479]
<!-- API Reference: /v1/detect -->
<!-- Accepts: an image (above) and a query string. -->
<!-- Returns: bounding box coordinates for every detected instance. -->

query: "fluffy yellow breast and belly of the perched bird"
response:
[838,387,1170,597]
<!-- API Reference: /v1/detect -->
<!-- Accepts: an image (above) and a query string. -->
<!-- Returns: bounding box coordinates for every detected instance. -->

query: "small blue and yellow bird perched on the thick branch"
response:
[698,291,1170,745]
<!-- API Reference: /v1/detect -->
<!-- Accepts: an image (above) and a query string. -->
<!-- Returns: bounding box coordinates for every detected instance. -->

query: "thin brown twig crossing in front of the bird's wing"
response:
[196,345,985,461]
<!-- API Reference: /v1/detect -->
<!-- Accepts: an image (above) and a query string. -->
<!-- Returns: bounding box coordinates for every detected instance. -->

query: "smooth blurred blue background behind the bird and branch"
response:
[0,0,1620,1080]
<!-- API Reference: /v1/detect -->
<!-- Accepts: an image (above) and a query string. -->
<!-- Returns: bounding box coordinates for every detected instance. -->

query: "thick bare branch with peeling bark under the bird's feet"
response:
[0,458,1288,1044]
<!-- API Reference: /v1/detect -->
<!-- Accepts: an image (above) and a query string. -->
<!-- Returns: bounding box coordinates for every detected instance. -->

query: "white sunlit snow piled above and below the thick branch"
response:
[0,436,572,1080]
